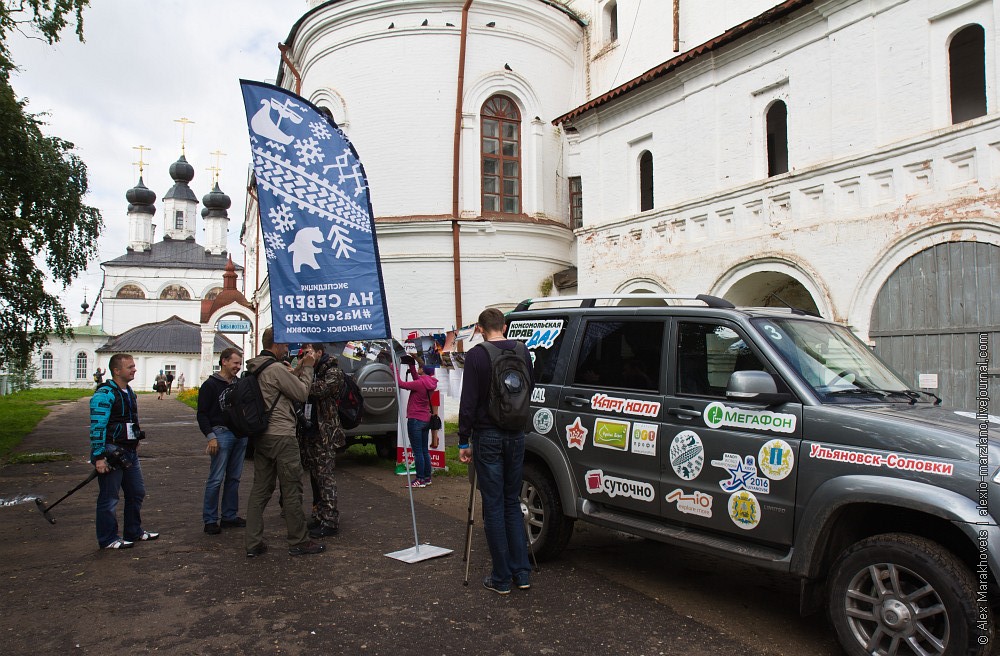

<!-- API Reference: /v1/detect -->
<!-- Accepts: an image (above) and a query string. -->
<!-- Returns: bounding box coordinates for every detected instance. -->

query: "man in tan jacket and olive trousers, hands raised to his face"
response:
[244,327,324,558]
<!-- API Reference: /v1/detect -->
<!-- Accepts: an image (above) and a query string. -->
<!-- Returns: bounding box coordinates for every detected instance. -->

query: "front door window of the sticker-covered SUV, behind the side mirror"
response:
[675,321,766,398]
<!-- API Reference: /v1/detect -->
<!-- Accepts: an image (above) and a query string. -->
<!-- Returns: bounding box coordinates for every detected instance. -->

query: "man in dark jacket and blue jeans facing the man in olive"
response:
[198,348,247,535]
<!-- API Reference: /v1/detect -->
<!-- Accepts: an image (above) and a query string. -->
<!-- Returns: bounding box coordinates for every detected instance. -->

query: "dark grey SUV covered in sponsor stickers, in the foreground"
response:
[507,294,1000,656]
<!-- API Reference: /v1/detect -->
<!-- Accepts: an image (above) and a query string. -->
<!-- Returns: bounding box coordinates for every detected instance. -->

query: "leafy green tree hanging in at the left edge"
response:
[0,0,102,370]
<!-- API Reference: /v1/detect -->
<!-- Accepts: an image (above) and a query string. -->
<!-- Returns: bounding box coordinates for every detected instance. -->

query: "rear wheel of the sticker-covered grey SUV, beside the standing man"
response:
[521,464,573,560]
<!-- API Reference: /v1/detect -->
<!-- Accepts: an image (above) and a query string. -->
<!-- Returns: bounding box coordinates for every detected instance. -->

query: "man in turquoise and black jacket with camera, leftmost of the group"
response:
[90,353,160,549]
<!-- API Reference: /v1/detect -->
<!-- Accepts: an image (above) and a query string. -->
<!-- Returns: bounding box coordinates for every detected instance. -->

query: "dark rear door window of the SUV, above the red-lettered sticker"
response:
[573,321,664,392]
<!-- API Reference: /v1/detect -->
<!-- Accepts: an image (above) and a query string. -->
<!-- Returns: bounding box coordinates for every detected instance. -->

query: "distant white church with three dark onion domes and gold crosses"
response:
[34,154,253,391]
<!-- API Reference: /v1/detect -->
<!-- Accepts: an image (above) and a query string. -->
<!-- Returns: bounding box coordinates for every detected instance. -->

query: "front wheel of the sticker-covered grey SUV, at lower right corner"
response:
[829,533,993,656]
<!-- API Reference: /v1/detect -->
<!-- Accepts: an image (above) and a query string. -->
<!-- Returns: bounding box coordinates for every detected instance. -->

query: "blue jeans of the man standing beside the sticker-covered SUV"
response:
[472,428,531,584]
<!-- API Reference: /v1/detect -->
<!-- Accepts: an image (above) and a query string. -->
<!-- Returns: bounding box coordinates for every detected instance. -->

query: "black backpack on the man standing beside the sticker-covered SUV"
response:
[483,342,531,431]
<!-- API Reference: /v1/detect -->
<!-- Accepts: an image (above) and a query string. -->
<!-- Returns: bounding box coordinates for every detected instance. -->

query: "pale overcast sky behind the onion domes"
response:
[11,0,307,325]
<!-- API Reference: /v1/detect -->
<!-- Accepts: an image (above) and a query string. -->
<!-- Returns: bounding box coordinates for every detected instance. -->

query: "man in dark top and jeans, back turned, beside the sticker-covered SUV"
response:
[458,308,534,594]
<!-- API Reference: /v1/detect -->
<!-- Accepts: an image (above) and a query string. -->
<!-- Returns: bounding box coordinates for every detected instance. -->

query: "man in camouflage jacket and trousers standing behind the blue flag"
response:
[299,343,346,538]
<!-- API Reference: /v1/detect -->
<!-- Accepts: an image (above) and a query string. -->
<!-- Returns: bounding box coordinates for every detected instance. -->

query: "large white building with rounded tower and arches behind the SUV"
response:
[243,0,1000,405]
